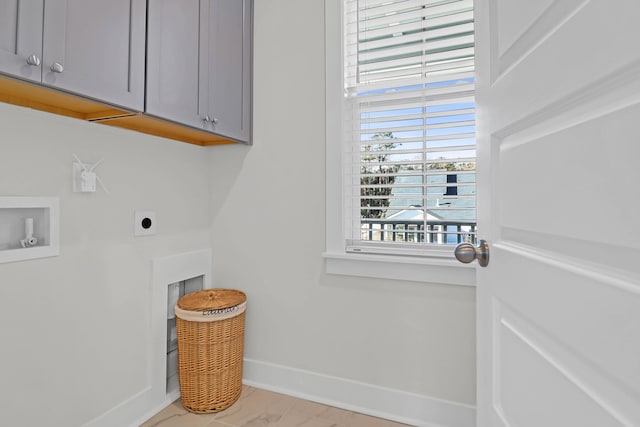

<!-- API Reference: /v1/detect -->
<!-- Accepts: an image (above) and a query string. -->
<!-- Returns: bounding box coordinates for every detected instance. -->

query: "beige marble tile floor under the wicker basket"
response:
[141,386,406,427]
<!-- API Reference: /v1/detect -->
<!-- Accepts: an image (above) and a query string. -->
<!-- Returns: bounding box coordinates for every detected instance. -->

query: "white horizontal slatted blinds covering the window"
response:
[344,0,476,255]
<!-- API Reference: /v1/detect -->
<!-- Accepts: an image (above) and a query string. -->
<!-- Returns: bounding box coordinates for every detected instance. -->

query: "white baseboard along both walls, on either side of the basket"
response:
[84,359,476,427]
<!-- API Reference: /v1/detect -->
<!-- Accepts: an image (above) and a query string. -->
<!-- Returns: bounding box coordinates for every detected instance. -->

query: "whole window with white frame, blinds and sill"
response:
[324,0,475,286]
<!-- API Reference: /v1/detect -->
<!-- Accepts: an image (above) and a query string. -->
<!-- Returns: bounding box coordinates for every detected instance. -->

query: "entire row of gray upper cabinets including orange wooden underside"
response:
[0,0,253,145]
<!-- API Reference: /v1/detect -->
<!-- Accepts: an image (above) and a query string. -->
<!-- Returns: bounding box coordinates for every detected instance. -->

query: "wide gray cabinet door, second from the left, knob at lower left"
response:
[42,0,146,111]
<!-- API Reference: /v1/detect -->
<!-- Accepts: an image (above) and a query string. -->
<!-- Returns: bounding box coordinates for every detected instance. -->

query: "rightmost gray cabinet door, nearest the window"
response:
[206,0,253,143]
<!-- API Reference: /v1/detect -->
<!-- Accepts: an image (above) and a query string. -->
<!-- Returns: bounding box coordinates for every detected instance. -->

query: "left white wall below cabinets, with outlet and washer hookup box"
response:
[0,103,211,427]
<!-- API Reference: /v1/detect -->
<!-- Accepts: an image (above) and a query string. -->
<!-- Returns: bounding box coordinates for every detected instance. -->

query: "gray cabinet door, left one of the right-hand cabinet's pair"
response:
[146,0,207,129]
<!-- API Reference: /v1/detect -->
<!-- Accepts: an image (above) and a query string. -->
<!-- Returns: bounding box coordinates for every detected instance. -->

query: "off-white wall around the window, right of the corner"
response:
[211,0,475,422]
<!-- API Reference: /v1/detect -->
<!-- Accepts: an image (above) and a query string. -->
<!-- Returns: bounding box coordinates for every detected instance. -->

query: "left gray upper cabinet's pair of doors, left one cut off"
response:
[0,0,146,111]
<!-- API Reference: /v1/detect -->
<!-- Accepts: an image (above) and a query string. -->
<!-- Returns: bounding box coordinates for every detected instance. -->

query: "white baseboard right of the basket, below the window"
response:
[243,359,476,427]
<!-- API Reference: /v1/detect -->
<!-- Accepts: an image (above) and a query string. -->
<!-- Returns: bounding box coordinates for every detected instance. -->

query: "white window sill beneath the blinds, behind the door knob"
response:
[323,252,476,286]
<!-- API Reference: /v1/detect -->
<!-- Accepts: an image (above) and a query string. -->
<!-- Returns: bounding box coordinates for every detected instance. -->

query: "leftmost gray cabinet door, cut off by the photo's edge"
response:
[0,0,44,82]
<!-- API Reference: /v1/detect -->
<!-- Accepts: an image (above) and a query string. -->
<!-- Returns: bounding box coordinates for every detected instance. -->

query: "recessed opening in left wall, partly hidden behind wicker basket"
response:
[166,276,204,394]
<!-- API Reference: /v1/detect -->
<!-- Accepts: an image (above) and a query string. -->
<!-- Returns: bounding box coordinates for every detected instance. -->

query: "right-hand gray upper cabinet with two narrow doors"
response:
[146,0,253,143]
